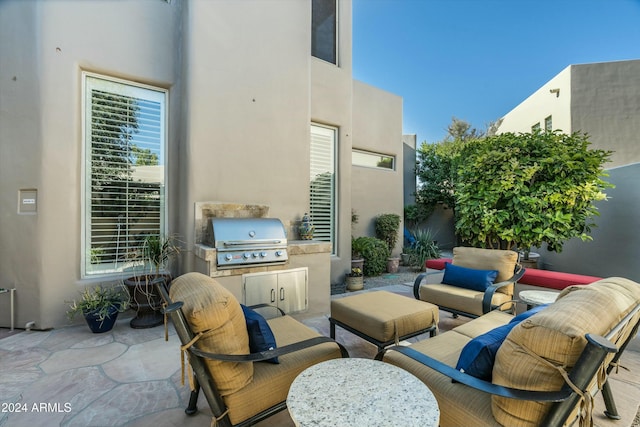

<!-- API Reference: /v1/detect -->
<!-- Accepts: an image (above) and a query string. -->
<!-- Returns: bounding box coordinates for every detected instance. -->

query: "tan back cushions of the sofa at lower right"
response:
[492,278,640,427]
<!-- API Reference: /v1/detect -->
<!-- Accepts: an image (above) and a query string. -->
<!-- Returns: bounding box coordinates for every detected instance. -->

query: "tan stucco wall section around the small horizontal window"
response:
[349,81,404,256]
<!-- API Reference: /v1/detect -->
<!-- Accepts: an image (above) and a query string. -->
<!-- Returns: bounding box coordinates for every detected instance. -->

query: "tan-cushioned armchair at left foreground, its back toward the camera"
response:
[155,273,349,427]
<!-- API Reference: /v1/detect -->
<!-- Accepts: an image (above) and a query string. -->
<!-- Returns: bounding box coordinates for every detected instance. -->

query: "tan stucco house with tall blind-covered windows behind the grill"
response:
[0,0,403,329]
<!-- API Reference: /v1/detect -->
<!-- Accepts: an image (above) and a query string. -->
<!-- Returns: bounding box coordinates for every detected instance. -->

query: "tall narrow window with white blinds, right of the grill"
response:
[309,125,336,254]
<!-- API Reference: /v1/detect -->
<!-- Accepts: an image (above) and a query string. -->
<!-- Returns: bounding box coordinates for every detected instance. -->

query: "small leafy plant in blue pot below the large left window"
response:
[67,285,129,334]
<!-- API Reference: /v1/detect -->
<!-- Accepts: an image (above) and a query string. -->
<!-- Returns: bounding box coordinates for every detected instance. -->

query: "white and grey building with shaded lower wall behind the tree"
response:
[498,60,640,280]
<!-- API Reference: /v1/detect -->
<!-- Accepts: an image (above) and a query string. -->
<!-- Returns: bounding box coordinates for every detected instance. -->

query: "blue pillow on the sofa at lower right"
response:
[456,304,548,381]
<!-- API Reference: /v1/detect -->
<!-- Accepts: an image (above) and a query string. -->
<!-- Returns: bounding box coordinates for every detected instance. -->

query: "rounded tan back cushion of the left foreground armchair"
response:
[169,273,253,396]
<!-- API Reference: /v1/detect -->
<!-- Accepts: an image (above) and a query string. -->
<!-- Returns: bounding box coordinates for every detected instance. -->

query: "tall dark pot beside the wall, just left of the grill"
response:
[124,274,171,329]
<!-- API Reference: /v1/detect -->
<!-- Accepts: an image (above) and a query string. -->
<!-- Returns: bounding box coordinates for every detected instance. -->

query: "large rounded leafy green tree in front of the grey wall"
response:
[455,131,612,251]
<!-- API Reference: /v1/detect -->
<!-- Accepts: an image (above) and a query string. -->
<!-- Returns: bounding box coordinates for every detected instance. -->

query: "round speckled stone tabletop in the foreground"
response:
[287,358,440,427]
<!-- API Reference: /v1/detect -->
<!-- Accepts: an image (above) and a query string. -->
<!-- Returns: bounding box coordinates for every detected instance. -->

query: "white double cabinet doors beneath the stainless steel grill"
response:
[242,268,308,313]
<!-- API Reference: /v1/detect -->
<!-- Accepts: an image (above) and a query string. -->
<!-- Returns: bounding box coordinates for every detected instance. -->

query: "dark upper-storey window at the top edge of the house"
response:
[311,0,337,64]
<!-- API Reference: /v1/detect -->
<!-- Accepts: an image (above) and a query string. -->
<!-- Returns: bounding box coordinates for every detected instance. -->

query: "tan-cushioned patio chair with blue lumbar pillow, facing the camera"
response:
[413,247,525,317]
